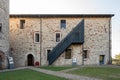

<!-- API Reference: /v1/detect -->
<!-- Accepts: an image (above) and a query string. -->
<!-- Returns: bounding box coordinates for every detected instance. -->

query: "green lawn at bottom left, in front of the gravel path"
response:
[0,69,67,80]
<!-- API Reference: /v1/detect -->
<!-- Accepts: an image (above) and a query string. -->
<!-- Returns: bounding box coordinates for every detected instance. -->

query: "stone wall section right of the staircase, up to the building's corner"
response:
[84,18,110,64]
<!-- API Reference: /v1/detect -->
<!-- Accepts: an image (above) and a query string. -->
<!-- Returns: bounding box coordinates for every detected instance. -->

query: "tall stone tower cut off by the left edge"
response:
[0,0,9,69]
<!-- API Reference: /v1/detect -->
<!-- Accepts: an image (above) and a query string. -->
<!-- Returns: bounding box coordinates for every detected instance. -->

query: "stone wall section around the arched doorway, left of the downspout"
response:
[10,18,40,67]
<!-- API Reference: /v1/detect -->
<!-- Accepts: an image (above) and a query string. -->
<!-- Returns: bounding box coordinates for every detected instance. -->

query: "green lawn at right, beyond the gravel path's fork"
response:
[68,67,120,80]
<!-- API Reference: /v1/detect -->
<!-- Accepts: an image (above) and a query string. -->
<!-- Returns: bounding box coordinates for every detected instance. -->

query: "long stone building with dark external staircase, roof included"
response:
[10,14,114,67]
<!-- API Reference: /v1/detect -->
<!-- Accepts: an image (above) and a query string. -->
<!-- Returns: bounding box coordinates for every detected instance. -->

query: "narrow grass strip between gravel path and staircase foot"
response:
[40,66,73,71]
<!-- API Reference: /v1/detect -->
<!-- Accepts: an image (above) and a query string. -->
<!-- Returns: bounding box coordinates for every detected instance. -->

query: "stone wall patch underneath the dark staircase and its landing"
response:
[53,44,82,66]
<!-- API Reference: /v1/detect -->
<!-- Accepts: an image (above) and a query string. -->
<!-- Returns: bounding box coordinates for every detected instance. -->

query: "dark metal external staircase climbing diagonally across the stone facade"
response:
[48,20,84,65]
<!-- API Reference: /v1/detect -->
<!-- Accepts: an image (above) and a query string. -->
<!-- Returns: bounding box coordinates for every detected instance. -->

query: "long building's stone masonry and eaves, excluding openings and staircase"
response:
[10,14,113,67]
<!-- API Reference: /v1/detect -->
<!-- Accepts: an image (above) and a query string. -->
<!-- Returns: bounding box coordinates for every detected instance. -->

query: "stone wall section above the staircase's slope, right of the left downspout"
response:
[42,18,82,65]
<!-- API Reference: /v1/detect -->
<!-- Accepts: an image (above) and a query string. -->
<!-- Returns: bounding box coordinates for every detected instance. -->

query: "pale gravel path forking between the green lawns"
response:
[0,67,101,80]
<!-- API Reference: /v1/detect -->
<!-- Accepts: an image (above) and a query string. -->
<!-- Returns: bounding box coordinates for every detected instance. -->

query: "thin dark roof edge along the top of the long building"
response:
[10,14,114,18]
